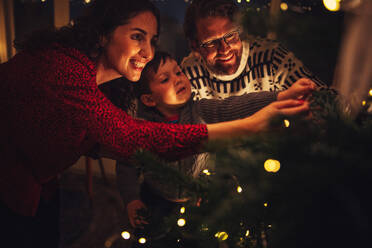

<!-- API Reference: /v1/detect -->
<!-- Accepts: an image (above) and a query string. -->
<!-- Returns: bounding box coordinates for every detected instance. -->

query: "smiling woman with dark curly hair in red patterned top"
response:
[0,0,307,247]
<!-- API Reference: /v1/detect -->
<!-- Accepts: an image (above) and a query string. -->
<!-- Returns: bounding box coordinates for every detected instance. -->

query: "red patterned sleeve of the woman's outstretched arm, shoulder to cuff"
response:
[52,46,208,159]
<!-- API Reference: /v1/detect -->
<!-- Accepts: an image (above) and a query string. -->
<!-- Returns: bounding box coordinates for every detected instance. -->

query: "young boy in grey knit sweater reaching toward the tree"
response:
[117,52,315,233]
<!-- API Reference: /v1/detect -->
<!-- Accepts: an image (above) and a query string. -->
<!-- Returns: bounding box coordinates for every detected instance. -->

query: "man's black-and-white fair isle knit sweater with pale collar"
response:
[181,38,324,100]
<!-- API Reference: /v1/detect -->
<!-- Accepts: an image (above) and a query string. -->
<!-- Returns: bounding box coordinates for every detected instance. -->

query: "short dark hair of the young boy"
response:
[134,51,173,98]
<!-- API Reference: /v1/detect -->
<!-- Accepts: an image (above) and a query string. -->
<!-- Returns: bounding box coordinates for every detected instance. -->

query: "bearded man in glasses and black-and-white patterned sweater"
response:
[181,0,324,100]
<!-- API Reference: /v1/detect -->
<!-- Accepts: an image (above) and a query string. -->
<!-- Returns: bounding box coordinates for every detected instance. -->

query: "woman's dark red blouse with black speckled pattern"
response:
[0,45,208,215]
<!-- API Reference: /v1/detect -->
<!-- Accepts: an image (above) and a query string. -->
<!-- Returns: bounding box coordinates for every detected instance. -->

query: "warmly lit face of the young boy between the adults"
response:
[146,58,191,116]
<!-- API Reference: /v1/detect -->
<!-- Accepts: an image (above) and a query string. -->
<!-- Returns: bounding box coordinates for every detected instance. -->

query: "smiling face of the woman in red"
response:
[97,11,158,84]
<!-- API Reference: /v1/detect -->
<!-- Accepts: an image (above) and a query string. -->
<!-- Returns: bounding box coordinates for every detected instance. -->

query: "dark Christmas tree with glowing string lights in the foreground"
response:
[116,1,372,248]
